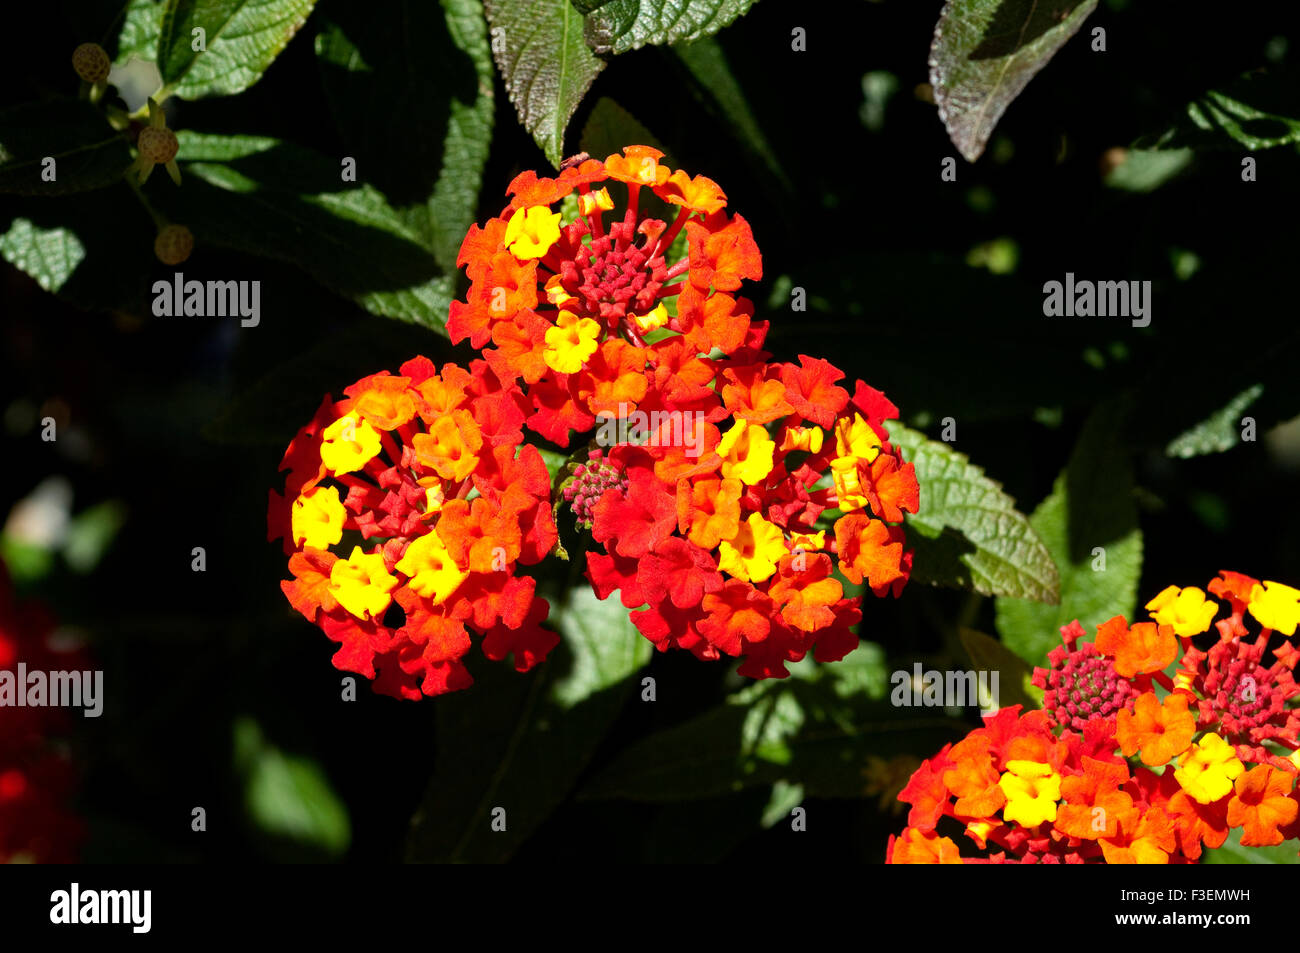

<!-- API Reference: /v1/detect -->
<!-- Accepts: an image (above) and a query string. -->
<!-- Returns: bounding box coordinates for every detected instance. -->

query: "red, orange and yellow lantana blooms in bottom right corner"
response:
[888,571,1300,863]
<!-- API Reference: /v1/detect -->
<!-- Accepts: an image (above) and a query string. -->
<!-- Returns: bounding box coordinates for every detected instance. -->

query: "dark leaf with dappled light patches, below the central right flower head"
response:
[579,644,965,811]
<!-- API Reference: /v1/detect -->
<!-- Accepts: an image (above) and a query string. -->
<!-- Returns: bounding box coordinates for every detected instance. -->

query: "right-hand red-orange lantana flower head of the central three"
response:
[576,371,919,679]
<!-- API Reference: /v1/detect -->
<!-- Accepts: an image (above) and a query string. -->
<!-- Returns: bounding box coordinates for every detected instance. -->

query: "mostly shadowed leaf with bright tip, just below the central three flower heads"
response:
[408,586,651,862]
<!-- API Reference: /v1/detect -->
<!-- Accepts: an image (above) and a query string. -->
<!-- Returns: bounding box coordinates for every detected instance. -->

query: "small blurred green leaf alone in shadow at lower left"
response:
[234,718,352,858]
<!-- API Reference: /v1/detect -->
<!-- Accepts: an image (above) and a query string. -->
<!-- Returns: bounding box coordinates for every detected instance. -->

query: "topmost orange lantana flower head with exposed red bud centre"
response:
[447,146,766,446]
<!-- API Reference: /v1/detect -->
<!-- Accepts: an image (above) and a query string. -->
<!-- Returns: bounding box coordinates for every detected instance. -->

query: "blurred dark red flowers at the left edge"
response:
[0,564,88,863]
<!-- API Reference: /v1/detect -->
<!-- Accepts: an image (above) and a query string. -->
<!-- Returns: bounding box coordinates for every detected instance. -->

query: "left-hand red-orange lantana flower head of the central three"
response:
[268,356,559,698]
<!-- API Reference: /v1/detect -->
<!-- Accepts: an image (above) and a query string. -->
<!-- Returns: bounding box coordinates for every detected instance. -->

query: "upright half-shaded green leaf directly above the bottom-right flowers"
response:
[997,404,1143,664]
